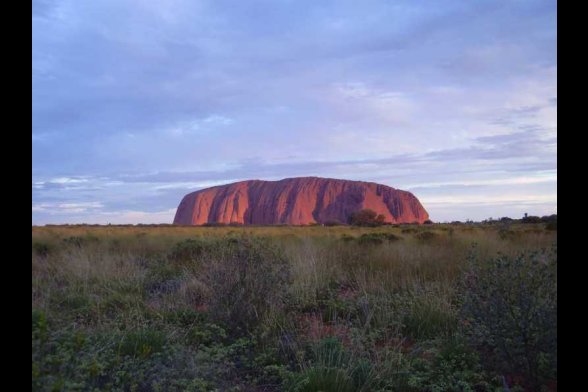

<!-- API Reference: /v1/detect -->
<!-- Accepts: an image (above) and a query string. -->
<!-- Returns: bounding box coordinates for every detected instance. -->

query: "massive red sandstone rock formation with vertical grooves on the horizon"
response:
[174,177,429,225]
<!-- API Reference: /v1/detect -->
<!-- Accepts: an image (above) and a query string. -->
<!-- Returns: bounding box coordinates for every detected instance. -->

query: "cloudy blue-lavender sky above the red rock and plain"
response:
[32,0,557,225]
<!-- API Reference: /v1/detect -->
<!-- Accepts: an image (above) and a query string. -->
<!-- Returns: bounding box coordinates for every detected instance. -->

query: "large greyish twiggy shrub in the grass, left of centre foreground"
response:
[199,238,290,335]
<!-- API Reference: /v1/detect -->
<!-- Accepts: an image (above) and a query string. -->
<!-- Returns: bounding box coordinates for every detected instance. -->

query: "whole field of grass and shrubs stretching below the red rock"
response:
[32,222,557,391]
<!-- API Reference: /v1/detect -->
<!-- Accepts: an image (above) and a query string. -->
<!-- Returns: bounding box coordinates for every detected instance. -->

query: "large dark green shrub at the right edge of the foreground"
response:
[461,250,557,390]
